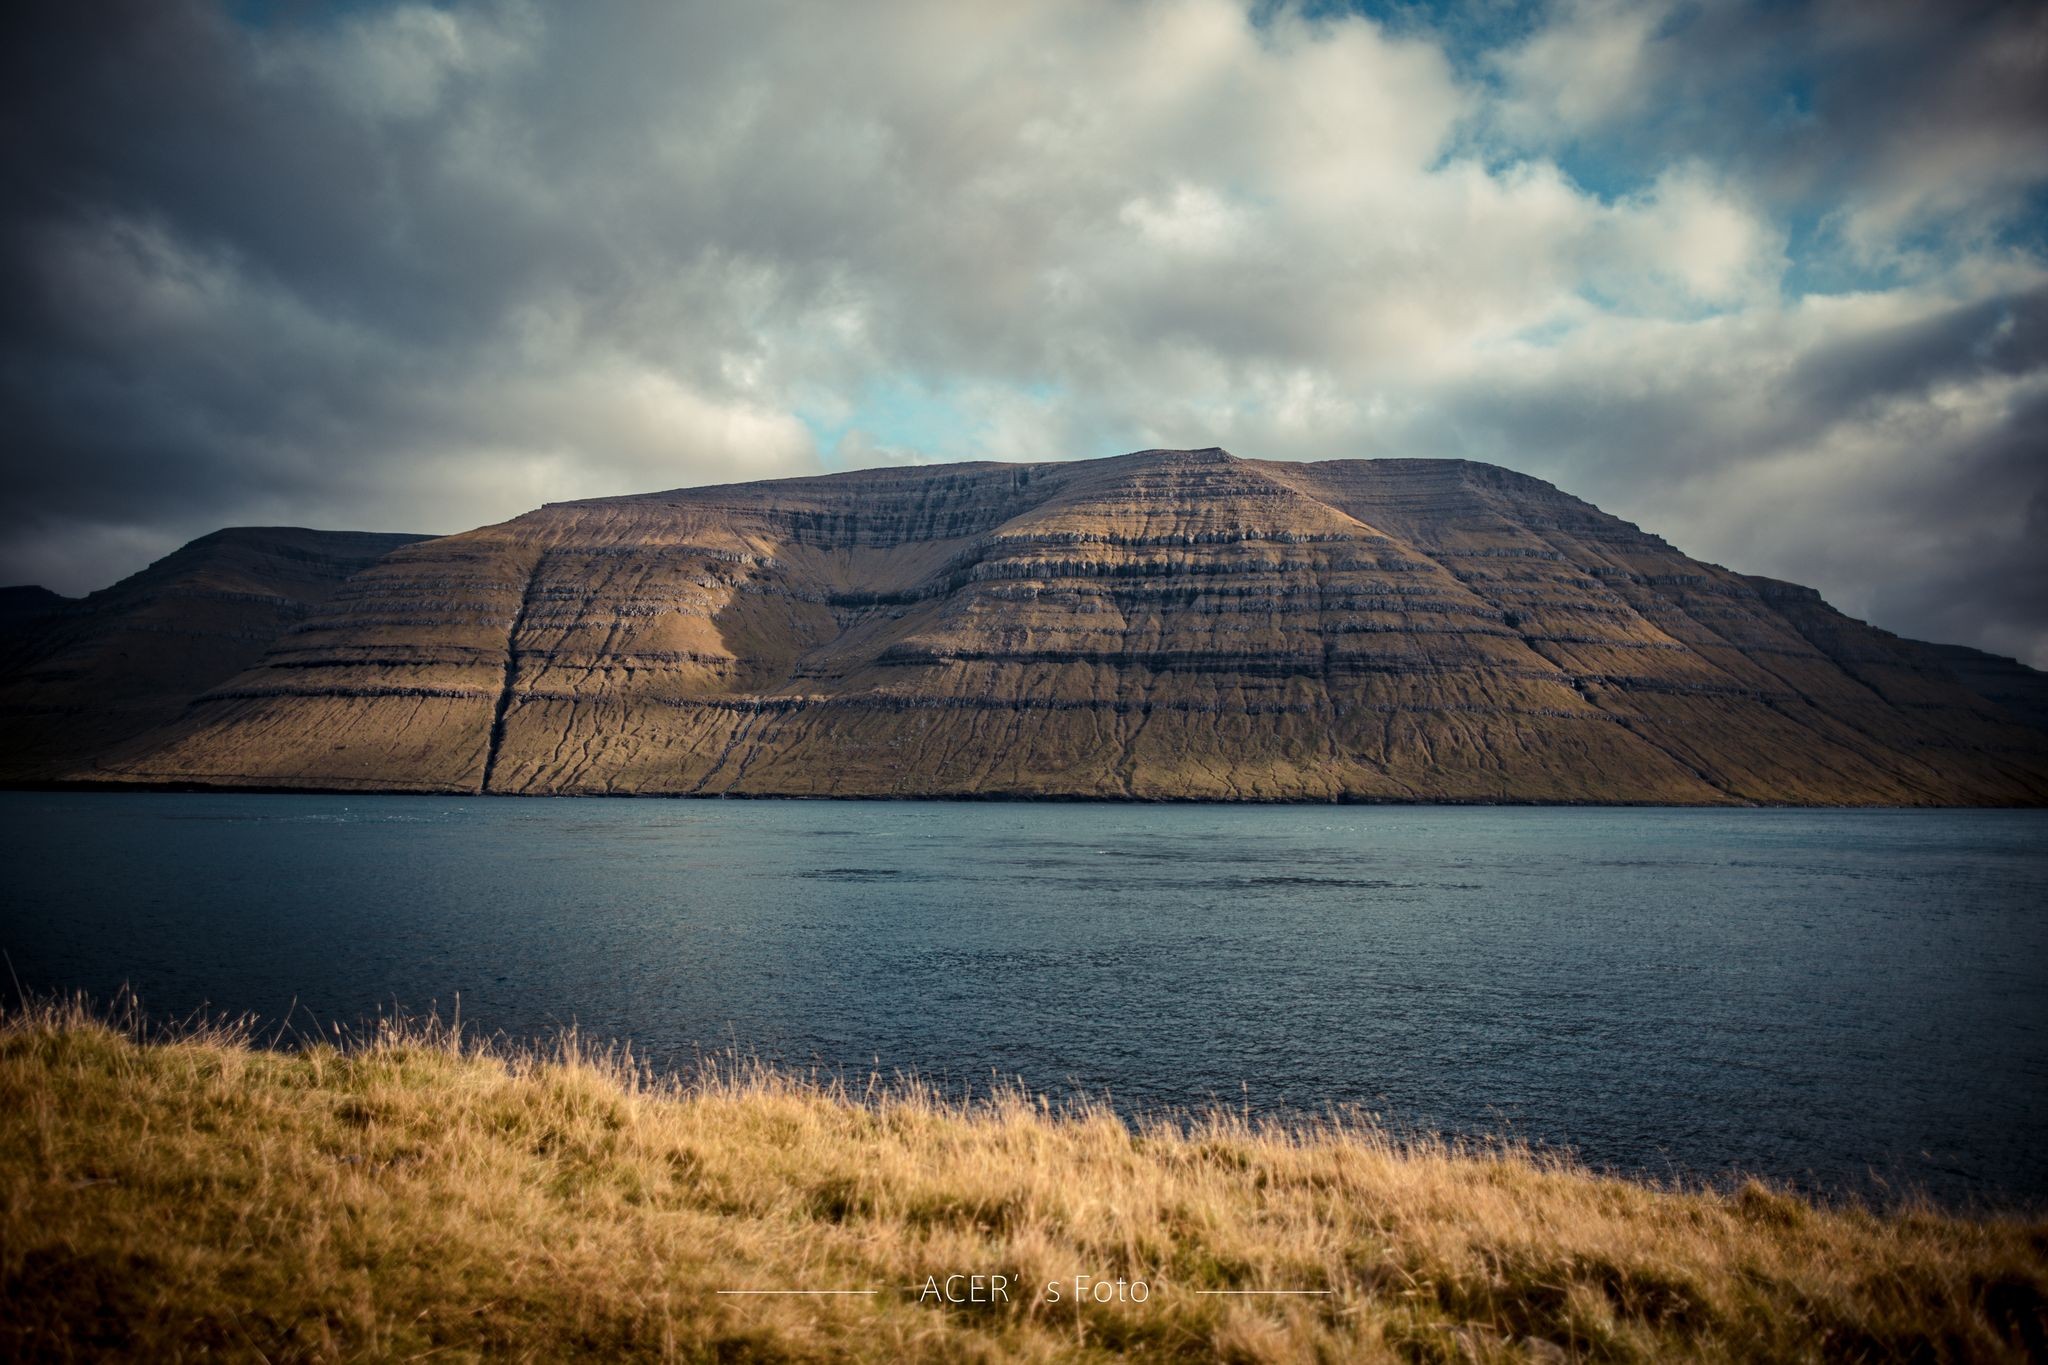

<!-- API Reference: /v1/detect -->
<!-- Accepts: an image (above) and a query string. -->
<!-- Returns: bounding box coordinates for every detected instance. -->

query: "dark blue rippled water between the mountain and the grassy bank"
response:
[0,794,2048,1203]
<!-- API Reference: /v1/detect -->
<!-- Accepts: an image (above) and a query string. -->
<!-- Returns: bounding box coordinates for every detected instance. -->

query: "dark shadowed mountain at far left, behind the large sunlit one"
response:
[0,526,422,782]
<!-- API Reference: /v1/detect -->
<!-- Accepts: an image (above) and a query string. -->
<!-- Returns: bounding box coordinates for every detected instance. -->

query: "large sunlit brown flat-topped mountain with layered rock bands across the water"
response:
[16,450,2048,804]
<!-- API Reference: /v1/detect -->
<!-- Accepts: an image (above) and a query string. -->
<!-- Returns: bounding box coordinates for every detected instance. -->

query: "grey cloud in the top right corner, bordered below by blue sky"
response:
[1481,0,2048,255]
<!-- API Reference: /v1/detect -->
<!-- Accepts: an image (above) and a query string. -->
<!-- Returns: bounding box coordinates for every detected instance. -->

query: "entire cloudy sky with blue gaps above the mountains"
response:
[0,0,2048,667]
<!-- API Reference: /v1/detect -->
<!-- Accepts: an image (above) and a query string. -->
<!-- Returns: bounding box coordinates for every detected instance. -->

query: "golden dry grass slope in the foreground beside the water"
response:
[0,1007,2048,1361]
